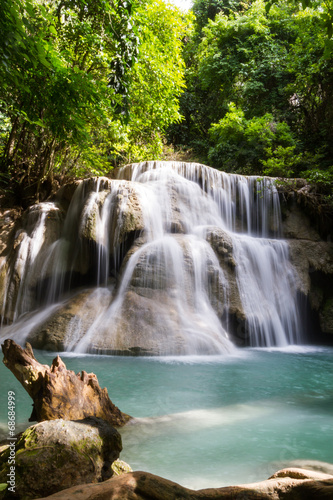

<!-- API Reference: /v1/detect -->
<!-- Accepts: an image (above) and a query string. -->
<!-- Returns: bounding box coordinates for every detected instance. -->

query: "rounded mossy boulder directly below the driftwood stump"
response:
[0,417,122,499]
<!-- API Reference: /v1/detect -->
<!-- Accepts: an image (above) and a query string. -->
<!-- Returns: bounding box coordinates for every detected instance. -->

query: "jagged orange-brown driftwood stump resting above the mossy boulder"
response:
[2,339,131,427]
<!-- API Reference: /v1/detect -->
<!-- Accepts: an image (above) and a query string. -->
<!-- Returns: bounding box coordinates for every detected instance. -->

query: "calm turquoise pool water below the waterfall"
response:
[0,346,333,489]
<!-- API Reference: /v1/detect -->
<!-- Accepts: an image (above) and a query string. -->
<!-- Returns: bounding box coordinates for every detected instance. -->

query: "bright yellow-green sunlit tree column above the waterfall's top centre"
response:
[114,0,192,162]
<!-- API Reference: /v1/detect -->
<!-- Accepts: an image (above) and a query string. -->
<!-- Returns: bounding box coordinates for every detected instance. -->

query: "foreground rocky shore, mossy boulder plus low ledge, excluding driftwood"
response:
[0,417,333,500]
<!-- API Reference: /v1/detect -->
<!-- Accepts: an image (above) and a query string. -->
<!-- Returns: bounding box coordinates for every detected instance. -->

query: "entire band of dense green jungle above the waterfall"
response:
[0,0,333,206]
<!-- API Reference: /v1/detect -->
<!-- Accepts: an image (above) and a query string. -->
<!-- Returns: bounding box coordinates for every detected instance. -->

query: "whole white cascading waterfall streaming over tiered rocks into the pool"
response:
[1,162,301,354]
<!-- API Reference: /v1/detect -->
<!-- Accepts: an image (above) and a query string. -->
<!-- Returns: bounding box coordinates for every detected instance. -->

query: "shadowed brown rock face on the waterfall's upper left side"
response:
[0,178,144,323]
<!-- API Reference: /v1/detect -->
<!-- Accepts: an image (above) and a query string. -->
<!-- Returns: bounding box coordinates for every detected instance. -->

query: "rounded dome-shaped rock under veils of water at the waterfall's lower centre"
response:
[23,230,233,355]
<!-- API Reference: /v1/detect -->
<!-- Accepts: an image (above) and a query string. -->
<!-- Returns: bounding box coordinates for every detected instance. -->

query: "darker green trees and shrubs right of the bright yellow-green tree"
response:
[170,0,333,183]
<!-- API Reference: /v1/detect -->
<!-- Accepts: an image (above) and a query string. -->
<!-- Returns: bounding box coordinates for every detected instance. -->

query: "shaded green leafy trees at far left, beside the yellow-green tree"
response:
[0,0,137,199]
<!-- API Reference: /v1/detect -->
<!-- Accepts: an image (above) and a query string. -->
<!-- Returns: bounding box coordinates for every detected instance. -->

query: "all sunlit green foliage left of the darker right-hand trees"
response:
[0,0,189,203]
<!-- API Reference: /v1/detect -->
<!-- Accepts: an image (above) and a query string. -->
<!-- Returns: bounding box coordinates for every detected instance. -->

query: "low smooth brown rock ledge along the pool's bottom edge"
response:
[33,469,333,500]
